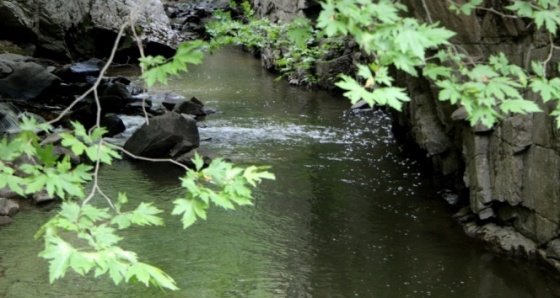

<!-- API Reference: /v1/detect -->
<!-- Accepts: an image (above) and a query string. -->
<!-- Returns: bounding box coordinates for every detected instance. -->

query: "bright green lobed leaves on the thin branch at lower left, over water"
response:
[0,118,274,290]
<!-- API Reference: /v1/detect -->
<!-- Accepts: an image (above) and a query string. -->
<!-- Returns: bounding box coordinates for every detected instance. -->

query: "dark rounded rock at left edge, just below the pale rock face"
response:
[0,59,60,100]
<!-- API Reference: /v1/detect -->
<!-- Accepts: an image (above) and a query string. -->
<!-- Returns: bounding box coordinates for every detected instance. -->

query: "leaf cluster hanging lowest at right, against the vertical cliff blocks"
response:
[423,50,540,127]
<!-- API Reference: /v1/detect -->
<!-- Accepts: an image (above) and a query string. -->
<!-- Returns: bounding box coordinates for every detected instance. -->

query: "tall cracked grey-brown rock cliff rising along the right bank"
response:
[254,0,560,269]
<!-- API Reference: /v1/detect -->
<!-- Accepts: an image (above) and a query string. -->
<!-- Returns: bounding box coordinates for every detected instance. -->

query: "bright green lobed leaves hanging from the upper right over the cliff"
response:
[317,0,560,127]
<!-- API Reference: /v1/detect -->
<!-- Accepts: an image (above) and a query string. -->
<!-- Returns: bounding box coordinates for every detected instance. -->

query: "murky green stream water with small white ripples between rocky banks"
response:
[0,50,560,298]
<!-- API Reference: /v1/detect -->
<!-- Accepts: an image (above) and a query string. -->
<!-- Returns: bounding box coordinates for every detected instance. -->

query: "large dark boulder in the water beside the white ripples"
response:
[124,112,200,158]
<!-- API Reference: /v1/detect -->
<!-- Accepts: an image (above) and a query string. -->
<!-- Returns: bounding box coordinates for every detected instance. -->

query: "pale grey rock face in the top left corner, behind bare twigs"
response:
[0,0,177,59]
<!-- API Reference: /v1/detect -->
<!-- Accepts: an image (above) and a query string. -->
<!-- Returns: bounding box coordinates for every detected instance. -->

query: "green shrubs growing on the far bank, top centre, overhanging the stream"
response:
[206,2,342,85]
